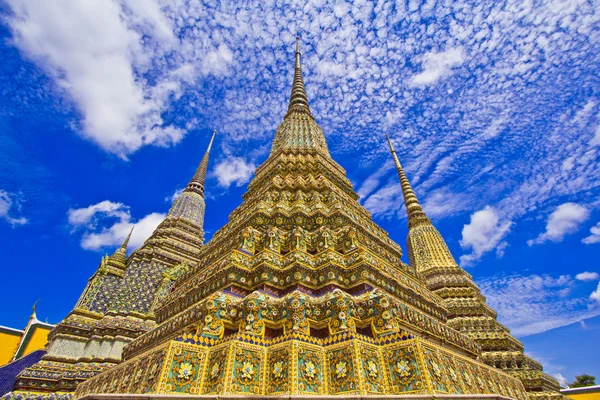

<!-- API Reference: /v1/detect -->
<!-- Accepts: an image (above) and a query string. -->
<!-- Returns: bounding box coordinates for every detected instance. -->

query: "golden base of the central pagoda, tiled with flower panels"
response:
[75,332,528,400]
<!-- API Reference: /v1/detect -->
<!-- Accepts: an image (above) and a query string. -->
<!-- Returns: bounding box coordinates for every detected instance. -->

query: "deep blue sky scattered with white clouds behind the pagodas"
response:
[0,0,600,388]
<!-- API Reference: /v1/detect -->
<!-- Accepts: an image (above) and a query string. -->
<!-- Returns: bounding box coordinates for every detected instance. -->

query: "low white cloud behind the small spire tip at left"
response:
[68,200,166,250]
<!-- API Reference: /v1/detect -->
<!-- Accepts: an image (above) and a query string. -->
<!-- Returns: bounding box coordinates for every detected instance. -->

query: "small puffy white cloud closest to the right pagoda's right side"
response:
[460,206,512,266]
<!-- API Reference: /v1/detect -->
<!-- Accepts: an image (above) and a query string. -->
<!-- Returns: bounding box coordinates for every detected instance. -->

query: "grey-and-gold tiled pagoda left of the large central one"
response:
[6,133,215,399]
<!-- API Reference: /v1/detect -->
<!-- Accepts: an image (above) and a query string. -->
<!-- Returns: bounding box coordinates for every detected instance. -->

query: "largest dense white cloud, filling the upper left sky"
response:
[8,0,233,158]
